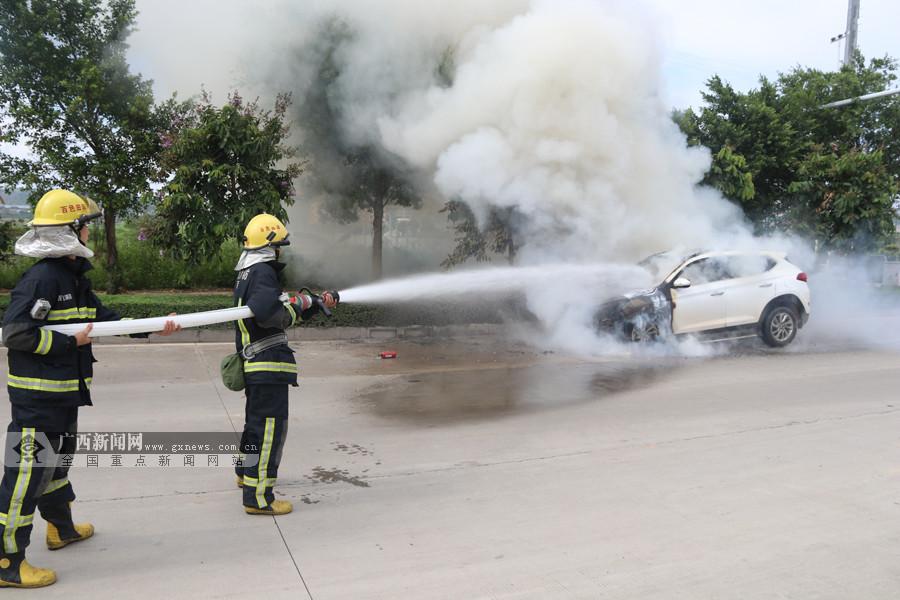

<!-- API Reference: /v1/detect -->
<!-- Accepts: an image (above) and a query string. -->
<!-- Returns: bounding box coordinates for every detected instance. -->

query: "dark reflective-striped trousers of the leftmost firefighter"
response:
[0,405,78,555]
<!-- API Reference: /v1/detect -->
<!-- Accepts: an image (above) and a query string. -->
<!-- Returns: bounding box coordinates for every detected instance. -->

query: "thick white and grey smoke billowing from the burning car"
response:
[130,0,896,351]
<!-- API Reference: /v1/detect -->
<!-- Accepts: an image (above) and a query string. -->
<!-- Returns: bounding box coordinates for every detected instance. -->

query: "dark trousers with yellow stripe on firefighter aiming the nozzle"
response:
[235,383,288,508]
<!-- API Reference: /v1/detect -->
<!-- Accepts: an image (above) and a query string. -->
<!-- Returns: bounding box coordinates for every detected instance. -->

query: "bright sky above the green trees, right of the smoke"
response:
[644,0,900,108]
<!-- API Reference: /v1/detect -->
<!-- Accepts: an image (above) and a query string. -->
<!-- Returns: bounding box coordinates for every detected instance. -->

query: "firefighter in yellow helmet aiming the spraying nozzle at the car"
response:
[234,213,337,515]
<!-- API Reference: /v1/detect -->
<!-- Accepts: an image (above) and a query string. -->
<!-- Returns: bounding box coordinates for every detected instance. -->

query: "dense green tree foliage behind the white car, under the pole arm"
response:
[674,55,900,249]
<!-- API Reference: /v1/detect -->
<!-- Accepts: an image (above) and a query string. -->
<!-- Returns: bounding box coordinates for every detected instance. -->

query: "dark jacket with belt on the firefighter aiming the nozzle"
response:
[234,261,318,385]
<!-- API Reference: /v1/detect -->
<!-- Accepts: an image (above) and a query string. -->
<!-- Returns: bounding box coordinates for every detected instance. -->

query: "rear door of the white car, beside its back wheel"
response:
[725,254,778,327]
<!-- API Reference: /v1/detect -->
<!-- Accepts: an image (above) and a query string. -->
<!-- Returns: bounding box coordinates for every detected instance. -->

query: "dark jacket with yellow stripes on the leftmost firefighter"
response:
[3,257,119,407]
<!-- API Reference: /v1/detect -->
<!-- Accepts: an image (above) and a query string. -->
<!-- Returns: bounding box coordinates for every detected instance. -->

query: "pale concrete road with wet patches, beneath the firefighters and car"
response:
[3,337,900,600]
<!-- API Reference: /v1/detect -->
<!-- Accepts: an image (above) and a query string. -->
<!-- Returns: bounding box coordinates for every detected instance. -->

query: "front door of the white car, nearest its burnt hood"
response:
[672,257,728,333]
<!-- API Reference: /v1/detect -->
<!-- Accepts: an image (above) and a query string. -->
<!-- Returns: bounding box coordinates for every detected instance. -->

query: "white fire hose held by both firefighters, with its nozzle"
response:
[0,288,340,338]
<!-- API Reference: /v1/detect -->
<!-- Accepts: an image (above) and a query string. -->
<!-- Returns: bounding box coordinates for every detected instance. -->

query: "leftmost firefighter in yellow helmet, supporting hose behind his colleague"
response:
[0,190,179,588]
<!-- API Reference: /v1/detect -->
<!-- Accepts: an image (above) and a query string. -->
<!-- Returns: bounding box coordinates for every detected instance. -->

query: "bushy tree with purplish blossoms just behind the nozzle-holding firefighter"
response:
[151,92,302,264]
